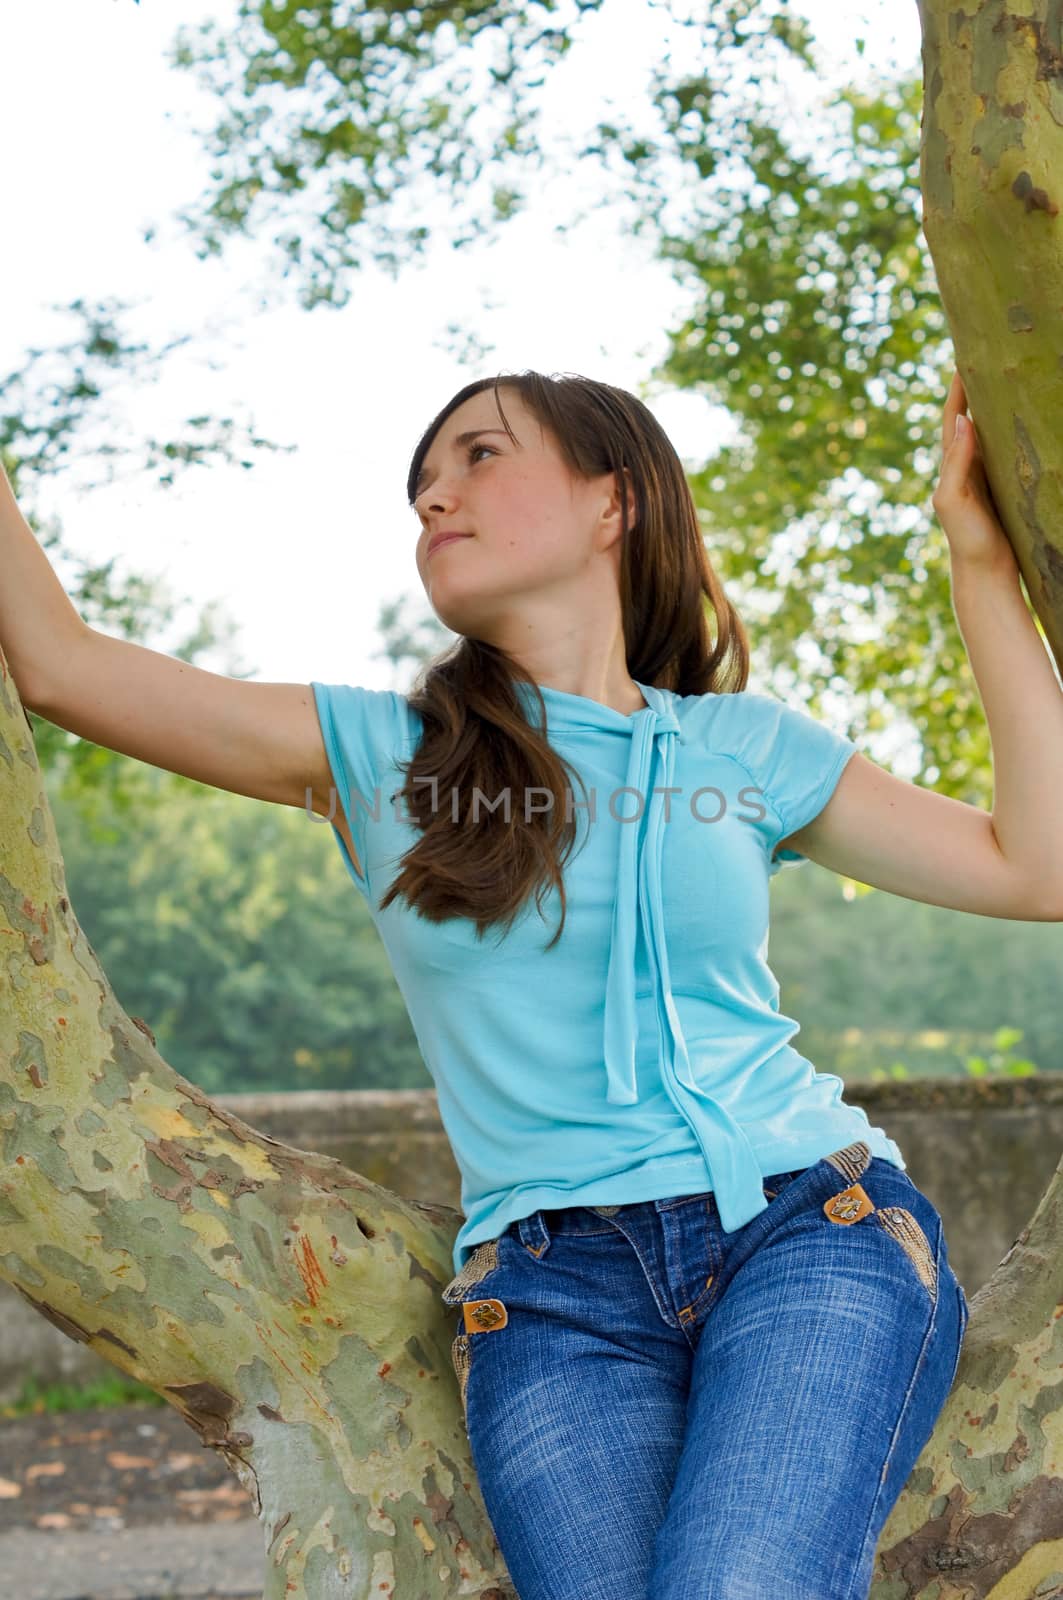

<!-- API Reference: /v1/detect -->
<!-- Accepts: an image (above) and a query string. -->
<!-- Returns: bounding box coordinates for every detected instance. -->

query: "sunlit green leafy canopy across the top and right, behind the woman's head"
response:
[166,0,1056,803]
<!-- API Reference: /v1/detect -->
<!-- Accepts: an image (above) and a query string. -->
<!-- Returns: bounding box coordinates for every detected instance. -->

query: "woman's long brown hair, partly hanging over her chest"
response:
[381,371,749,949]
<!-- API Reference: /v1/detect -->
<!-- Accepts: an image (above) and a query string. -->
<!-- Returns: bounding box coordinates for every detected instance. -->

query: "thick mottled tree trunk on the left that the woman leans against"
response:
[0,653,512,1600]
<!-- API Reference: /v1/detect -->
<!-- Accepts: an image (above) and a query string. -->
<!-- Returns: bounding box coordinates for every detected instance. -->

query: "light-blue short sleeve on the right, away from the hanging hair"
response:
[733,691,858,877]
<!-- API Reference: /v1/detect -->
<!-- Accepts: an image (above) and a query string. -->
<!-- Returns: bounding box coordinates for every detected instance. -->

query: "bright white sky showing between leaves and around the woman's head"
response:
[0,0,919,688]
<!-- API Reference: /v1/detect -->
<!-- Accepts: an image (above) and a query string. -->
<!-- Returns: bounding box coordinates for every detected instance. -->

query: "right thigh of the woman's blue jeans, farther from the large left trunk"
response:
[648,1147,967,1600]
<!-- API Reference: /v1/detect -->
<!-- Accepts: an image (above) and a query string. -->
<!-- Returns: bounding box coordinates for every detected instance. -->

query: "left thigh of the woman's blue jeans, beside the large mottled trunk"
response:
[447,1208,692,1600]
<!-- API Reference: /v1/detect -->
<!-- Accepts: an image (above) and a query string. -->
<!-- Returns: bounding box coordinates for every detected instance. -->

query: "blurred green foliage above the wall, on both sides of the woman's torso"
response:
[45,757,1063,1093]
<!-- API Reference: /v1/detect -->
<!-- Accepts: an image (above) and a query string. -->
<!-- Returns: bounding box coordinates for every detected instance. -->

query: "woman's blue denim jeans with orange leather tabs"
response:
[443,1142,967,1600]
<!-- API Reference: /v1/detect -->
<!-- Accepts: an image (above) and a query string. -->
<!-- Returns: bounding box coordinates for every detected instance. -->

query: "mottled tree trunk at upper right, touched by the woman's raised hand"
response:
[917,0,1063,672]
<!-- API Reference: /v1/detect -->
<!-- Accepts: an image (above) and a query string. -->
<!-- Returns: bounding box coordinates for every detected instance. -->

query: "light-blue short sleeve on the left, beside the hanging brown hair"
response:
[311,683,410,899]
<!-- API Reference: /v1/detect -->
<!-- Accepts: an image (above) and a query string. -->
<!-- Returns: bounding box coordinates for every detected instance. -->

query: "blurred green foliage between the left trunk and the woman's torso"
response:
[45,757,427,1094]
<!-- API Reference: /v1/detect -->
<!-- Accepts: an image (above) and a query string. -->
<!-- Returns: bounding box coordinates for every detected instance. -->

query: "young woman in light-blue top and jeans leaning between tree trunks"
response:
[0,373,1063,1600]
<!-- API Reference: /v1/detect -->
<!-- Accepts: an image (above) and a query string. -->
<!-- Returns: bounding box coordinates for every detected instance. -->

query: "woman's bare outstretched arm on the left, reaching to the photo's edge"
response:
[0,467,331,814]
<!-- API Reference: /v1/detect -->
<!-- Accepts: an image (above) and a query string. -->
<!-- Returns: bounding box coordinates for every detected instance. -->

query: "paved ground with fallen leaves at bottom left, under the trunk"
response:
[0,1406,264,1600]
